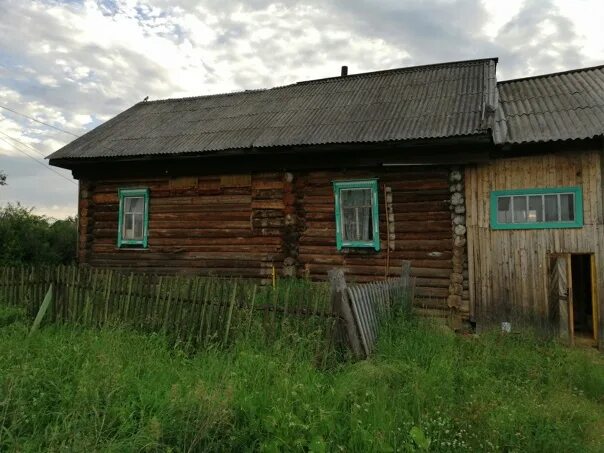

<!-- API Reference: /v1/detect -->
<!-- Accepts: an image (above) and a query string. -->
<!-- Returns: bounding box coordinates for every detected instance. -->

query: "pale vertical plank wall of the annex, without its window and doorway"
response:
[466,150,604,330]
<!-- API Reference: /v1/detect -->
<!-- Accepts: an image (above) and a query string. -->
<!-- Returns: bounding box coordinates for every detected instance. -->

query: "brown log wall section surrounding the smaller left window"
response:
[79,173,285,279]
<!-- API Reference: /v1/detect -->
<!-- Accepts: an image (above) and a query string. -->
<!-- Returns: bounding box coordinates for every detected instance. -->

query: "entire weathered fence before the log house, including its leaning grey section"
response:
[0,262,413,357]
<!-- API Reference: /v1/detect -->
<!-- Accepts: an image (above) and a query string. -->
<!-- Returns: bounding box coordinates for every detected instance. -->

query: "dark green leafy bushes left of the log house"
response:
[0,204,77,265]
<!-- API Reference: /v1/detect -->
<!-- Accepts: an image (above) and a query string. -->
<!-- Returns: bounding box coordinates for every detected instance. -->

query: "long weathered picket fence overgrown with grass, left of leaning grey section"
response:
[0,266,337,345]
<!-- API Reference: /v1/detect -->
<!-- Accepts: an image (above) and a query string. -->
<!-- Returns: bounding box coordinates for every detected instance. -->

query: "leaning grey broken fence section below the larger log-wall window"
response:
[330,261,415,357]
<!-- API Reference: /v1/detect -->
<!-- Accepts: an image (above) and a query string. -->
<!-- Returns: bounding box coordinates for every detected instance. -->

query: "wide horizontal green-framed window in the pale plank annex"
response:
[490,186,583,230]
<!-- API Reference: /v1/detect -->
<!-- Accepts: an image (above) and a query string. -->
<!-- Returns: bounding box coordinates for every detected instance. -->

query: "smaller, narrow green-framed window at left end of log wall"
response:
[117,189,149,248]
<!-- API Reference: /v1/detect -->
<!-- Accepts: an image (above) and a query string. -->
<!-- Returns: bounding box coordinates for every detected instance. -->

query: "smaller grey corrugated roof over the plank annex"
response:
[494,65,604,144]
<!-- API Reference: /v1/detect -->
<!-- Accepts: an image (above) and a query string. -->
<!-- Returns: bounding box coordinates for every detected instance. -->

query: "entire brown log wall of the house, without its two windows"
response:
[80,167,458,317]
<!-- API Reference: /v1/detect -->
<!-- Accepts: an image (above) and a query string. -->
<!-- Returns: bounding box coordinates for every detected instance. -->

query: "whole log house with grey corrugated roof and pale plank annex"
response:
[50,59,604,344]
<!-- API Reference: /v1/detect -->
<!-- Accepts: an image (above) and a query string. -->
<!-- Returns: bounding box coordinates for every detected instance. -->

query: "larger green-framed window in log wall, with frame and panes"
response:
[333,179,380,251]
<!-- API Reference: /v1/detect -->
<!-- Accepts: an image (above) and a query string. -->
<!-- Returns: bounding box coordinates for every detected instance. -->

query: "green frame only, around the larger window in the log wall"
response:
[333,179,380,251]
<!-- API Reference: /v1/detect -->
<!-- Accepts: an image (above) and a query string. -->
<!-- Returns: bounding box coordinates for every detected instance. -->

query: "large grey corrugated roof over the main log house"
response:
[50,59,497,159]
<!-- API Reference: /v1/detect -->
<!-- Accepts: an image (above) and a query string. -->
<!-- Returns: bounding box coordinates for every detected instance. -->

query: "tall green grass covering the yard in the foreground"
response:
[0,307,604,452]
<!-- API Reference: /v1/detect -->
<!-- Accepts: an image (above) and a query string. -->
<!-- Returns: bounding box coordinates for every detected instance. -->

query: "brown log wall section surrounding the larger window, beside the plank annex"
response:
[295,167,453,316]
